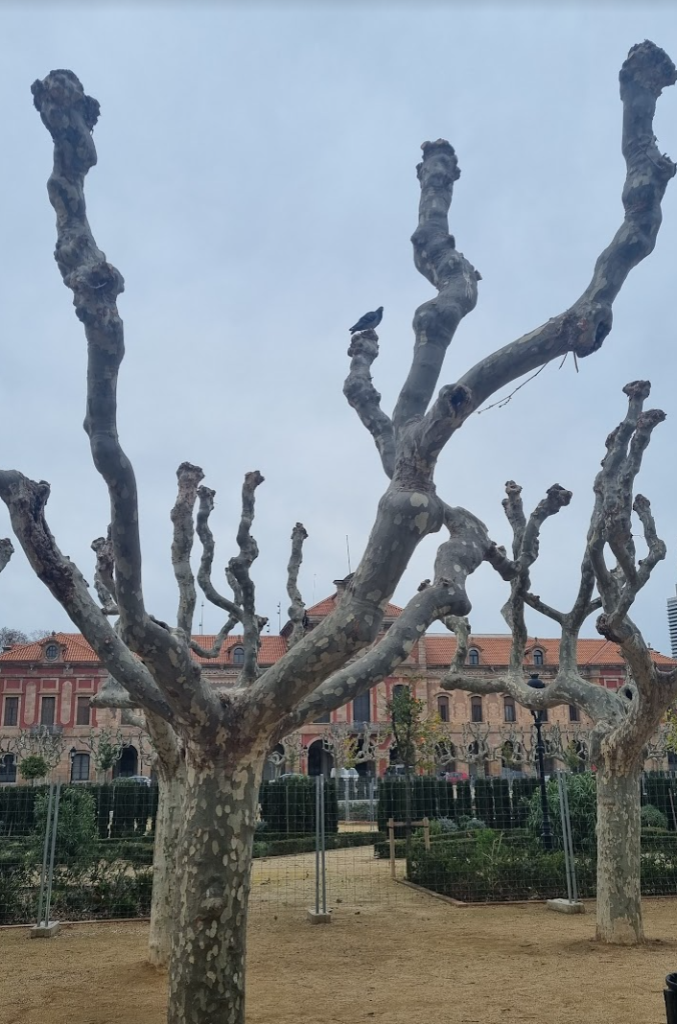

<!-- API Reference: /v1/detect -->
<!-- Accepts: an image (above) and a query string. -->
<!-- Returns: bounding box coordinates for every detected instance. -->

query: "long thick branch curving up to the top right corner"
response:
[421,40,677,447]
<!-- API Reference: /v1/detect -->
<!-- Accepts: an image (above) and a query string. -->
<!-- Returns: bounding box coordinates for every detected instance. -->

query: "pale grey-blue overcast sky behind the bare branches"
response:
[0,0,677,650]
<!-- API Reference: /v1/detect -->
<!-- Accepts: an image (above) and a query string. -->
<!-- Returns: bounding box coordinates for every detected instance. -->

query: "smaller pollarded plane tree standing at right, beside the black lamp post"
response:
[441,381,677,944]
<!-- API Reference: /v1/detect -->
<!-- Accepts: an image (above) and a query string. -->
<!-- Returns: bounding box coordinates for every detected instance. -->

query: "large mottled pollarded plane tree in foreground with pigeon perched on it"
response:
[0,42,676,1024]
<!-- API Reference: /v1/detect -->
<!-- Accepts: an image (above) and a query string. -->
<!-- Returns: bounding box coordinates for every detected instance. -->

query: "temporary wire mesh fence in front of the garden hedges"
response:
[0,773,677,925]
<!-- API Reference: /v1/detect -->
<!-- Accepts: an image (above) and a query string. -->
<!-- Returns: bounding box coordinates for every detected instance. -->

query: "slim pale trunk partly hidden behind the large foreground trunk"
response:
[149,765,185,967]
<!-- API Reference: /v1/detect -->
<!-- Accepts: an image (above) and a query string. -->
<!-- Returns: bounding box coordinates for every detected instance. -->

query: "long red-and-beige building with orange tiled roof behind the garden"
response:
[0,580,674,783]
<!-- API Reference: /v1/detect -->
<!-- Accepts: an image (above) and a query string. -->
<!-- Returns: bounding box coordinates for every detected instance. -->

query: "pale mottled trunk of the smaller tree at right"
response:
[597,767,644,945]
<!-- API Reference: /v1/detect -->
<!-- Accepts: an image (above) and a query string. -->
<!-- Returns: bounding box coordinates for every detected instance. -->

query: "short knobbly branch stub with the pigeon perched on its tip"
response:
[343,331,395,477]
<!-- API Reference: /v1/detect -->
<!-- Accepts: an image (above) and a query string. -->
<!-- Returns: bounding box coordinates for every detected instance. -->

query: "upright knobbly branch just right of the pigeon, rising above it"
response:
[392,138,479,431]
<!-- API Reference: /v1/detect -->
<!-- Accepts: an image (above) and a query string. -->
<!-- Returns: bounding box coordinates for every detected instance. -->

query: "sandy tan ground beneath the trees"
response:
[0,851,677,1024]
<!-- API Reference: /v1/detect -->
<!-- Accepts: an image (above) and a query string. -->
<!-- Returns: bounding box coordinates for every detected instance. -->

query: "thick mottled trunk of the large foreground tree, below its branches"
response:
[167,752,263,1024]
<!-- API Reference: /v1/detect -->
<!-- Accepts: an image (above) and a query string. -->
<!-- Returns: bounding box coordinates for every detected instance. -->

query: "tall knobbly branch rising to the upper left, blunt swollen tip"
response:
[32,71,210,724]
